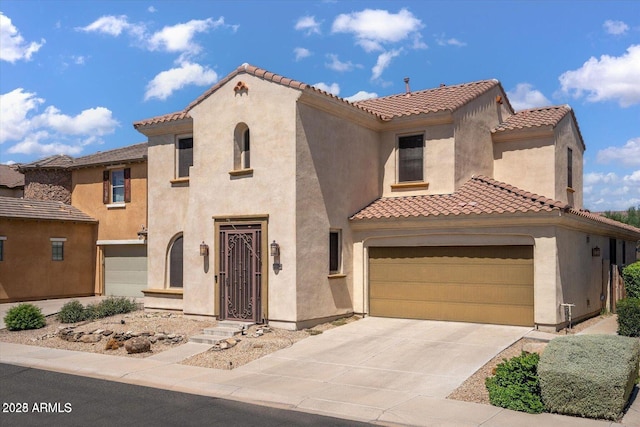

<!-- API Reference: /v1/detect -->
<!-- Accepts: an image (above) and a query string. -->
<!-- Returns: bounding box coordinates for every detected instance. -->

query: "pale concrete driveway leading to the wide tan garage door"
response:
[220,317,531,422]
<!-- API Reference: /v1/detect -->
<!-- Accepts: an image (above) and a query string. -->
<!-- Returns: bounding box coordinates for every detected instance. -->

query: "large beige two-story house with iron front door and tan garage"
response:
[134,64,640,329]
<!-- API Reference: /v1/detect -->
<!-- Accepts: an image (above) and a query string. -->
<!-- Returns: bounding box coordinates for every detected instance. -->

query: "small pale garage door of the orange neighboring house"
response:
[104,245,147,298]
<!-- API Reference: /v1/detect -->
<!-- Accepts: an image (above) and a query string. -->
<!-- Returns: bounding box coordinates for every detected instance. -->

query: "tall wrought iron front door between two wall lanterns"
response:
[220,224,262,323]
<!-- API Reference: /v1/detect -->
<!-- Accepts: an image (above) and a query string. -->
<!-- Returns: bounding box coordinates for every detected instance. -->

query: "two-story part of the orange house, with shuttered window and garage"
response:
[10,143,147,297]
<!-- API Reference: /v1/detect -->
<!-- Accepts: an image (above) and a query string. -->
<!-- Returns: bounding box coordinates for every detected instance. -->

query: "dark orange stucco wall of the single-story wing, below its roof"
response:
[0,219,97,302]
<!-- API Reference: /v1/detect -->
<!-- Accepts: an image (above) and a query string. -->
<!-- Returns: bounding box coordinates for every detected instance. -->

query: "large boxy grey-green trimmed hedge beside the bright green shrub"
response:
[538,335,640,420]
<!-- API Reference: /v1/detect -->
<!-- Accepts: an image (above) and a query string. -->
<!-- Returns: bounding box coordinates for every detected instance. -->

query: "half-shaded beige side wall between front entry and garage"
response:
[295,103,382,320]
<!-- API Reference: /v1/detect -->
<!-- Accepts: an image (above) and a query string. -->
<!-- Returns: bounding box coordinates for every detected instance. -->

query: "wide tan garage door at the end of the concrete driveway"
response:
[369,246,533,326]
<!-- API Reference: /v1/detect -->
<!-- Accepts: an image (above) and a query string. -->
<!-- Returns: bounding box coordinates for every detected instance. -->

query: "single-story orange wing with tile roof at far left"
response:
[0,196,98,303]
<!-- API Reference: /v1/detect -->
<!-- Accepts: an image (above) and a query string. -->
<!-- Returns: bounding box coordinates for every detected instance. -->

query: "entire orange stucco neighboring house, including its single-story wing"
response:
[0,143,147,301]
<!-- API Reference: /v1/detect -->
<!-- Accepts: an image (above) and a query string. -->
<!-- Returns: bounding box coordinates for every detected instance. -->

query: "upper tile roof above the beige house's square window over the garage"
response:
[355,80,500,120]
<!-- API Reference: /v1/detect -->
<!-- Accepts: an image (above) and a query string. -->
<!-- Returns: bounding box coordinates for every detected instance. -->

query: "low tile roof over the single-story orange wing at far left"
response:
[0,196,98,222]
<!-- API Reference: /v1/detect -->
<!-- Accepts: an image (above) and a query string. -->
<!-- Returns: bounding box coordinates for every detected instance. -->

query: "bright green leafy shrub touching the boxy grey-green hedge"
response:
[485,352,544,414]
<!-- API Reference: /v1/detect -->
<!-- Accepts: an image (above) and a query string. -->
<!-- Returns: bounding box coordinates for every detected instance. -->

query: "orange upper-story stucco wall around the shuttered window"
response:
[71,163,147,240]
